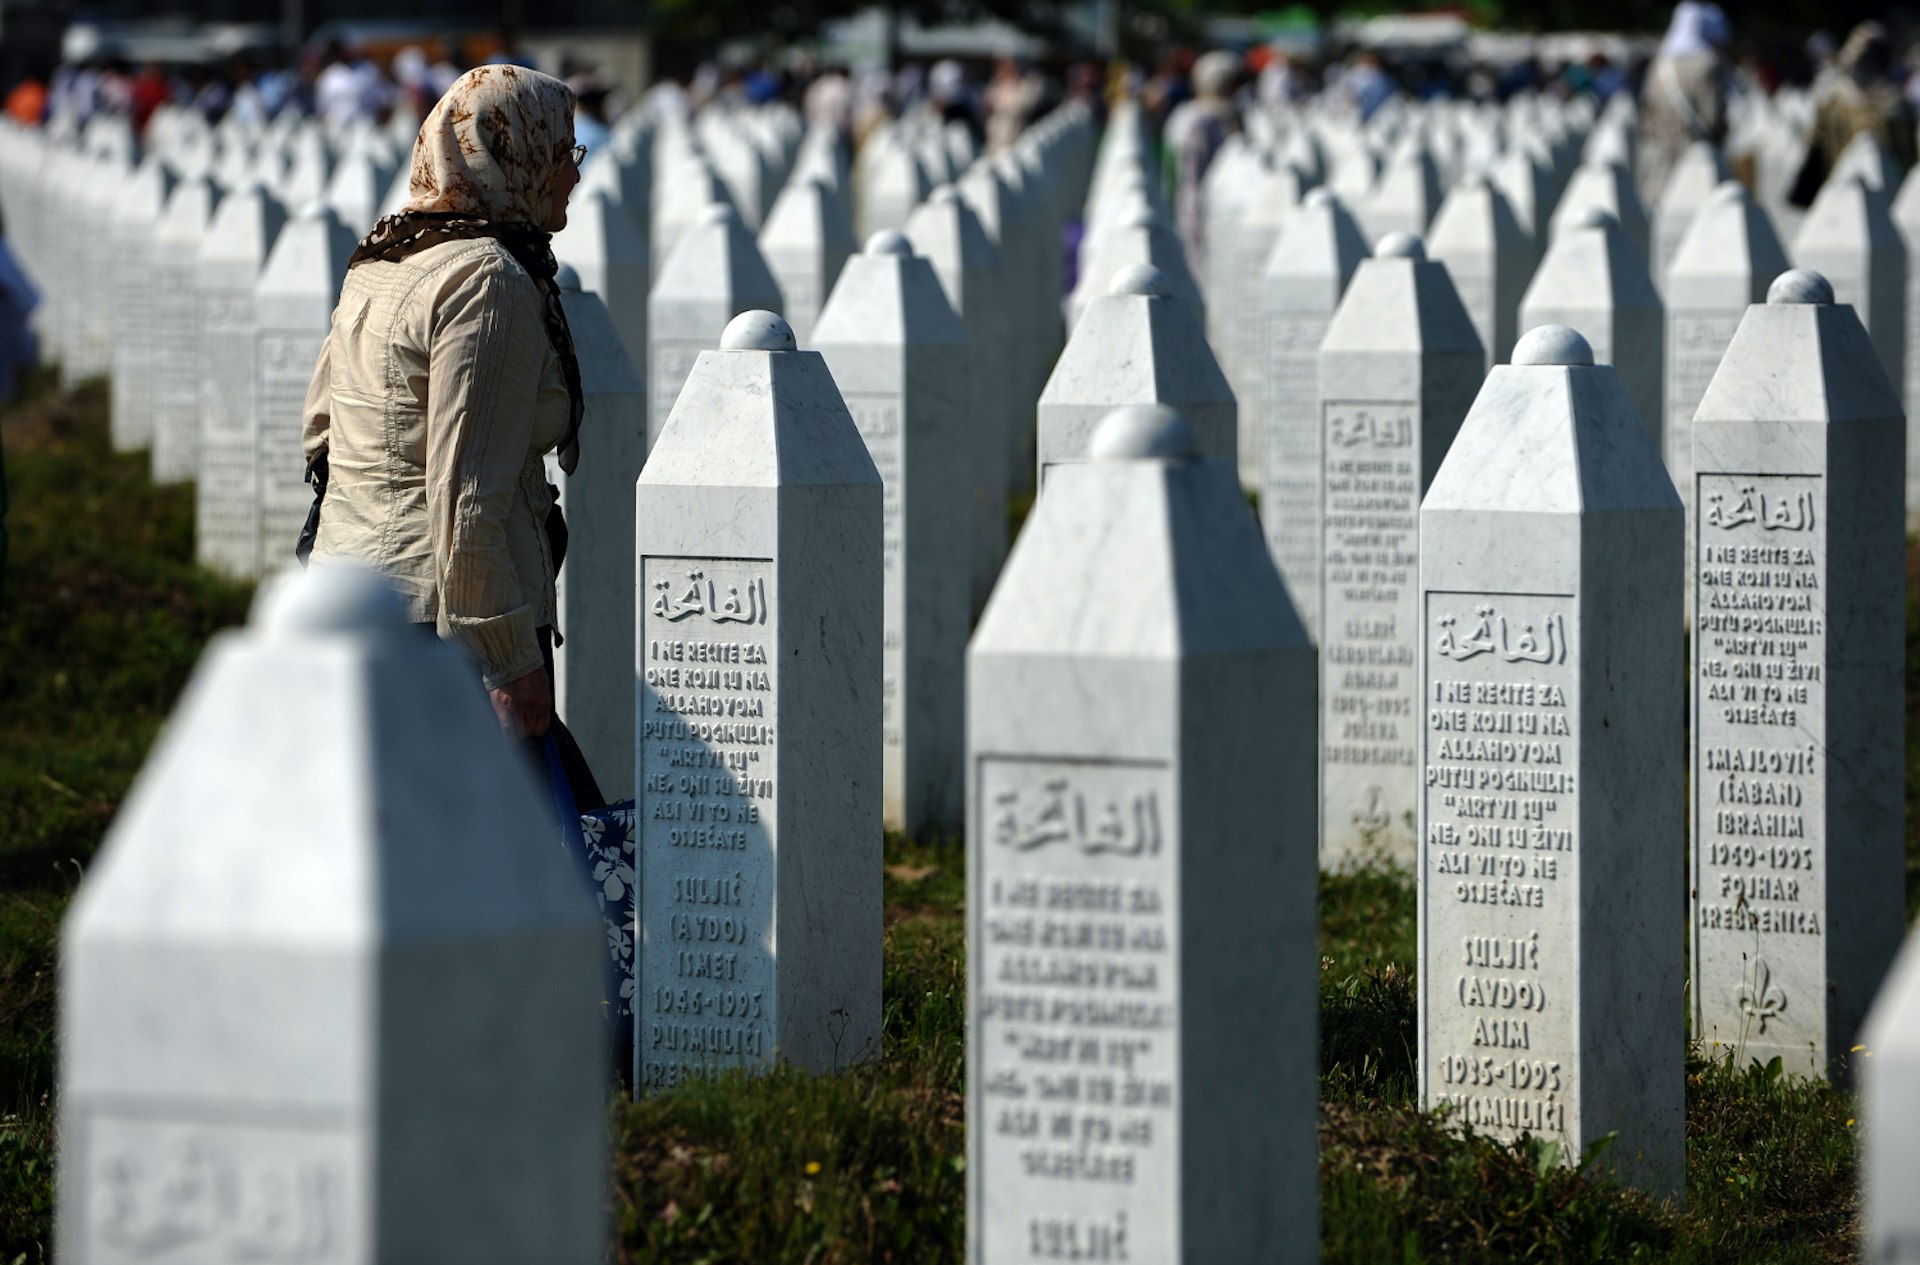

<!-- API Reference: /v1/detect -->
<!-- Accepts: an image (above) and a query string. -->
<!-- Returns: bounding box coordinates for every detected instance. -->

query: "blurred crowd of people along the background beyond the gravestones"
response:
[4,0,1920,222]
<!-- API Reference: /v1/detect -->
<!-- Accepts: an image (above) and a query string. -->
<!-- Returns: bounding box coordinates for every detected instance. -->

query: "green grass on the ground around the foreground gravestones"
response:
[0,378,1889,1265]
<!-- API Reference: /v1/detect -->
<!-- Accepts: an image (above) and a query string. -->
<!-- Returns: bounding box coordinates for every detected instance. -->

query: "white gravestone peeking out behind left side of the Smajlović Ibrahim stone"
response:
[1665,177,1788,552]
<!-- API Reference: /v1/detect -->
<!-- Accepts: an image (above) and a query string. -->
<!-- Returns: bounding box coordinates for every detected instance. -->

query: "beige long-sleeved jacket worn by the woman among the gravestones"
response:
[303,240,568,687]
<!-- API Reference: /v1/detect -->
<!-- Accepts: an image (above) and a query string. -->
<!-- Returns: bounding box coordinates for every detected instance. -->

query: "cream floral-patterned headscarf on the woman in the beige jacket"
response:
[401,65,574,228]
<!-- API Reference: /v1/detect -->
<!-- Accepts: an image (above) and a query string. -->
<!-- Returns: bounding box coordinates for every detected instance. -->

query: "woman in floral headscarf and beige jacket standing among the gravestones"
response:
[301,65,603,808]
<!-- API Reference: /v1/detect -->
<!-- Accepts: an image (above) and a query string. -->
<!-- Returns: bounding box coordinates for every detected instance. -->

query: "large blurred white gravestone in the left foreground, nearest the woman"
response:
[58,568,607,1265]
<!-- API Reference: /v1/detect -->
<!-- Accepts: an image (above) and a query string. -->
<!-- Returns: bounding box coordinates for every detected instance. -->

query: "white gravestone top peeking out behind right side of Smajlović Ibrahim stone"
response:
[1791,177,1907,408]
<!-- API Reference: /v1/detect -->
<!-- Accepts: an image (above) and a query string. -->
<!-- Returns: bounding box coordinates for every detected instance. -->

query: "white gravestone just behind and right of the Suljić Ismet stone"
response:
[814,232,977,835]
